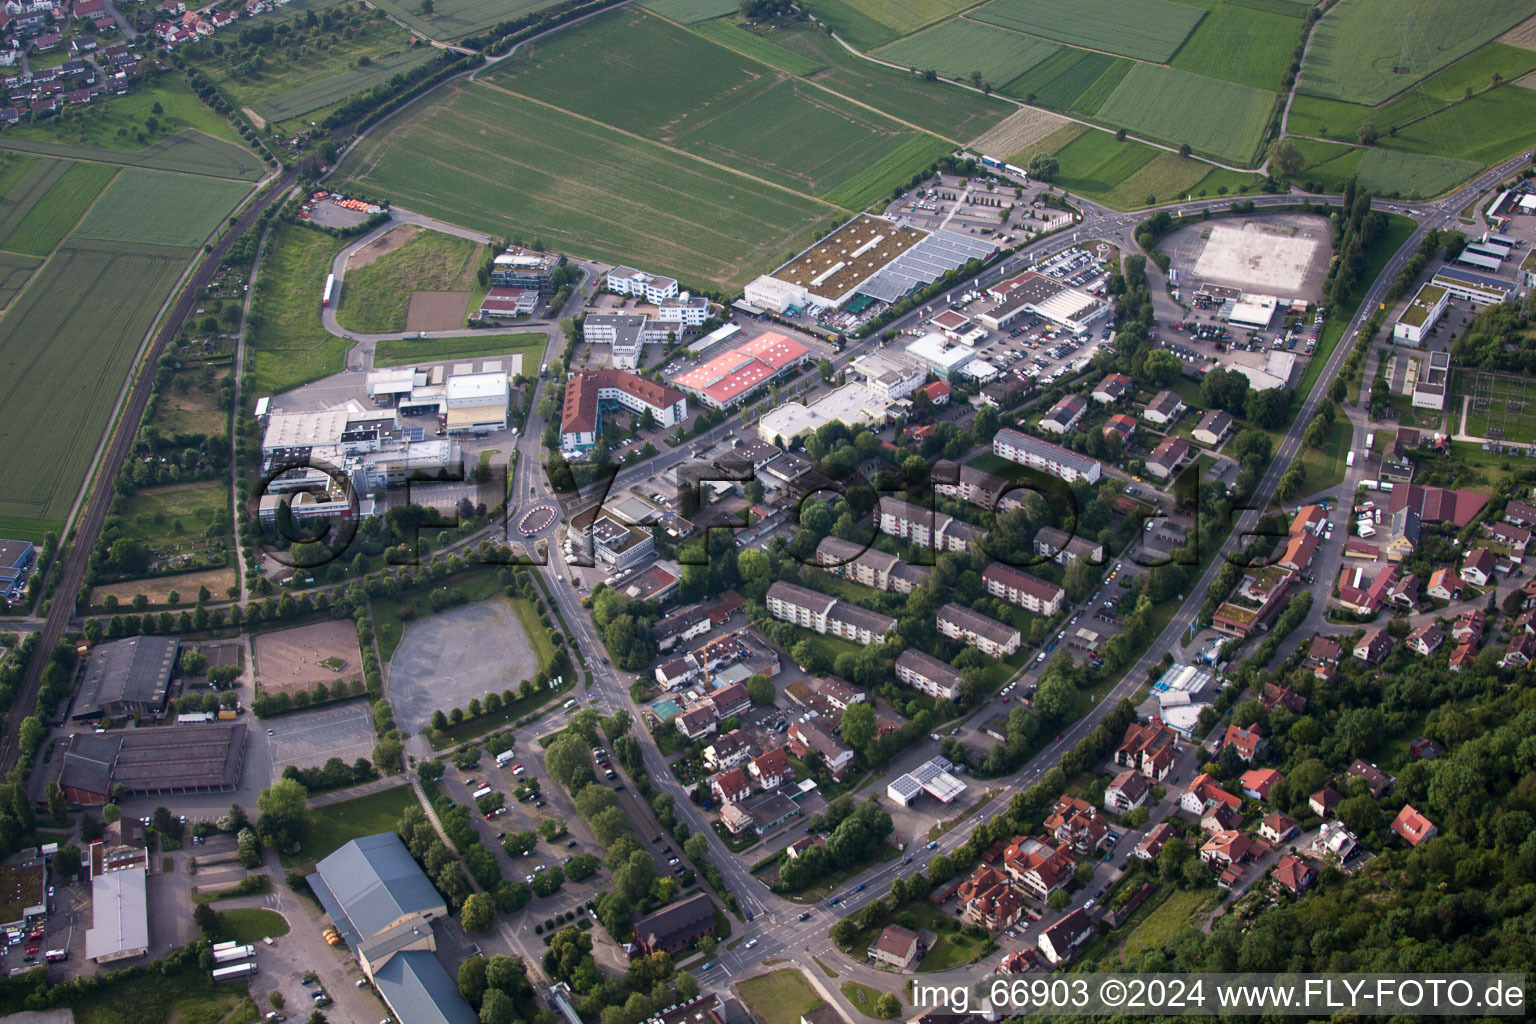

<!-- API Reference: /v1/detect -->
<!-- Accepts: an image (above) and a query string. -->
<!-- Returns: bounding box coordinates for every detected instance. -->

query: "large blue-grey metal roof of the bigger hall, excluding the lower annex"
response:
[310,832,444,945]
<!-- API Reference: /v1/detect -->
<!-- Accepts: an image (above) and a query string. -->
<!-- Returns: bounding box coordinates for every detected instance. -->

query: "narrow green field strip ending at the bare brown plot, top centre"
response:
[768,26,1015,144]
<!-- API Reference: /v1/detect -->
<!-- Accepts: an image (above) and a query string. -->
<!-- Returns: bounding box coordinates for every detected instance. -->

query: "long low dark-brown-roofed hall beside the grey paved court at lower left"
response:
[51,722,247,804]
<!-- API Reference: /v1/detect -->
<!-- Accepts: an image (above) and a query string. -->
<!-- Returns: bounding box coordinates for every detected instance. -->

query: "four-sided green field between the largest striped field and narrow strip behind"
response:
[677,78,954,199]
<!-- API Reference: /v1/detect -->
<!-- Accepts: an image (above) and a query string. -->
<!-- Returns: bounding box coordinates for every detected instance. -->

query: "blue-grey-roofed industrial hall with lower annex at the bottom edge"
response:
[309,832,479,1024]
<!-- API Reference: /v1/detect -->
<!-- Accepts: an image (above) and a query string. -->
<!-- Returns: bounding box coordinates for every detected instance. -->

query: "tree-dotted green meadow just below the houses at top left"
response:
[6,75,244,151]
